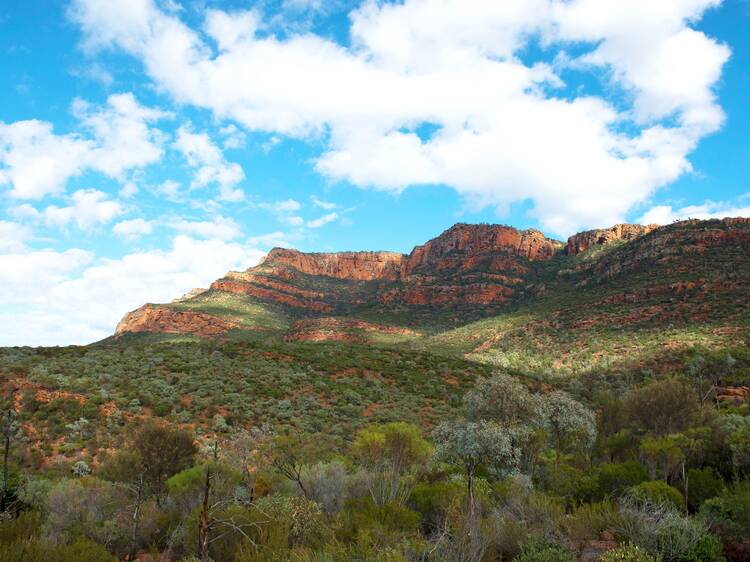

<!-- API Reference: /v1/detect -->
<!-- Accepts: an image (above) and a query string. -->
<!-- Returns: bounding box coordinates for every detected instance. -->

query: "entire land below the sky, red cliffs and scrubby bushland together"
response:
[0,219,750,562]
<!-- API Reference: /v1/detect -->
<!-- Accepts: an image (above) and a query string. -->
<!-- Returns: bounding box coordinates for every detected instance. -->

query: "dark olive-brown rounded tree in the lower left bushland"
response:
[133,422,198,504]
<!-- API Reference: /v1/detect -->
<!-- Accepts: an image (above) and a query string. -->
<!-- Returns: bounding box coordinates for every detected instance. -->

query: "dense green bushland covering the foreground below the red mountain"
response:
[0,350,750,562]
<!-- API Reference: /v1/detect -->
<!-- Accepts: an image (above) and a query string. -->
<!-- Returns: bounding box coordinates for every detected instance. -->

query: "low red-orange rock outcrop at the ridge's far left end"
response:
[115,304,237,336]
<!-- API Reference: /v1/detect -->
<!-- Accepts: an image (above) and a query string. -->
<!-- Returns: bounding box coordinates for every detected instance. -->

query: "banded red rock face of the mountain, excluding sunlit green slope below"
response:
[117,218,750,334]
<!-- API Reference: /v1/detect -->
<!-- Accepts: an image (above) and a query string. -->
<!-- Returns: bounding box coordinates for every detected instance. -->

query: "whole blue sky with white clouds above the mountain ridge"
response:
[0,0,750,345]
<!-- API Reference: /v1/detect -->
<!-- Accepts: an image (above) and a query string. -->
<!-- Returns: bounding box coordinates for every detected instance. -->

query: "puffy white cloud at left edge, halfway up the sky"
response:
[0,93,169,199]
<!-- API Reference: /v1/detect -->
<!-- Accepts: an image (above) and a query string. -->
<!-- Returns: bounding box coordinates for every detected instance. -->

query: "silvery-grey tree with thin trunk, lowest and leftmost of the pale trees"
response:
[433,420,528,520]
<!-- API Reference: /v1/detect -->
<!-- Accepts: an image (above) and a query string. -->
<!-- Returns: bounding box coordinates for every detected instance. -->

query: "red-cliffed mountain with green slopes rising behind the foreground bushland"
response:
[115,218,750,372]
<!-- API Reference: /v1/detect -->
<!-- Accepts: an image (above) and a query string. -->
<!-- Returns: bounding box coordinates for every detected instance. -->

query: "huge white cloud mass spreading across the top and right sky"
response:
[73,0,729,234]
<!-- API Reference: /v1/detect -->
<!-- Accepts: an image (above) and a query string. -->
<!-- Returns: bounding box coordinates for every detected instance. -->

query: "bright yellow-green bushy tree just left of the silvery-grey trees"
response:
[352,422,432,506]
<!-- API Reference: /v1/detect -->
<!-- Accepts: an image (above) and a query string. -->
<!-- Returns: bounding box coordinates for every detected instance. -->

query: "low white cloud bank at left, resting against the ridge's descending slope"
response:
[0,235,263,345]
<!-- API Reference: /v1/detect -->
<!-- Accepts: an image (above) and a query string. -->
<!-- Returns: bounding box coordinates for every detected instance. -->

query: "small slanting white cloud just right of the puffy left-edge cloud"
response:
[174,126,245,201]
